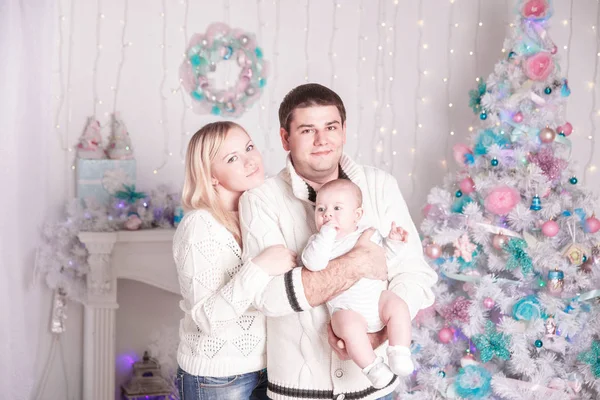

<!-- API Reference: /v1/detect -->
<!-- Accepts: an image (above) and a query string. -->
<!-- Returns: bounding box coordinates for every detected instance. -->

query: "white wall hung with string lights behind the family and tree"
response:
[14,0,600,399]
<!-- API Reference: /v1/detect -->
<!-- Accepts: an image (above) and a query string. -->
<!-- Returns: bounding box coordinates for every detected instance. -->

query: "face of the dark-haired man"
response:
[280,106,346,181]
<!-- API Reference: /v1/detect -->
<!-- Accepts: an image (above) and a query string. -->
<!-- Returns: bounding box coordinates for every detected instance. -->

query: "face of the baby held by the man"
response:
[315,188,362,238]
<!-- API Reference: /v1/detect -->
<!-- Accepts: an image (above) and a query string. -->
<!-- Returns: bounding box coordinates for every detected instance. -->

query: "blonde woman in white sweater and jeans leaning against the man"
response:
[173,122,296,400]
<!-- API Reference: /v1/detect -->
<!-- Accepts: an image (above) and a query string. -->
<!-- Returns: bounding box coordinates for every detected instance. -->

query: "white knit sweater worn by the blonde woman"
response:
[173,210,270,377]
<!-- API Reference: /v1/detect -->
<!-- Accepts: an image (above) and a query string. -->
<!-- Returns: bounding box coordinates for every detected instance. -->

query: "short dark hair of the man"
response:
[279,83,346,133]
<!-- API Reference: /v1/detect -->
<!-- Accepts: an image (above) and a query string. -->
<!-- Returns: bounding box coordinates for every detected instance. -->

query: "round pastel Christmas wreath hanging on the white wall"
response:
[179,23,267,117]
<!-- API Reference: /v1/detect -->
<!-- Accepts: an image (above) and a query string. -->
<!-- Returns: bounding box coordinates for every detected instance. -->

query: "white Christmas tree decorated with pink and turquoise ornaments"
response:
[400,0,600,400]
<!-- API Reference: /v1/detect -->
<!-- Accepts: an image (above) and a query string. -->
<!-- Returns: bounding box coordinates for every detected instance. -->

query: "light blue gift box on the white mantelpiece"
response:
[76,158,136,205]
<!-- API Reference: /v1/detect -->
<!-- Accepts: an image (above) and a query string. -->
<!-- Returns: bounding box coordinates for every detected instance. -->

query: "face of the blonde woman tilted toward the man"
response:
[211,127,265,192]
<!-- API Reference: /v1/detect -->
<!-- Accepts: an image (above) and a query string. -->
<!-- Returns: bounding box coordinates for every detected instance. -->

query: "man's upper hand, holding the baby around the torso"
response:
[342,228,388,281]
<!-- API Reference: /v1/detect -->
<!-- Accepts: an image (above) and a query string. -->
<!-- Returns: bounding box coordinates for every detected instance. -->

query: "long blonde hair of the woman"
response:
[181,121,245,243]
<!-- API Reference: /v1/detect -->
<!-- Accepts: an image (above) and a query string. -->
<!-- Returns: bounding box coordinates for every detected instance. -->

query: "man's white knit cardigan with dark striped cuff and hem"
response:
[240,156,437,400]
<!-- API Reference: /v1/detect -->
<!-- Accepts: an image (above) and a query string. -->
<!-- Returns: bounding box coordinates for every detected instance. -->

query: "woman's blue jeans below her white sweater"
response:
[177,368,269,400]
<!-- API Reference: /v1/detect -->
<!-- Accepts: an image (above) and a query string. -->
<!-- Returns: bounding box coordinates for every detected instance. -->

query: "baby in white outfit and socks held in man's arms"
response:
[302,179,414,389]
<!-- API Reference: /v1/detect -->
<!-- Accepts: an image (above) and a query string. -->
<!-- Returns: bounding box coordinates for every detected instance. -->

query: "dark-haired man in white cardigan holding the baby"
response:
[240,84,437,400]
